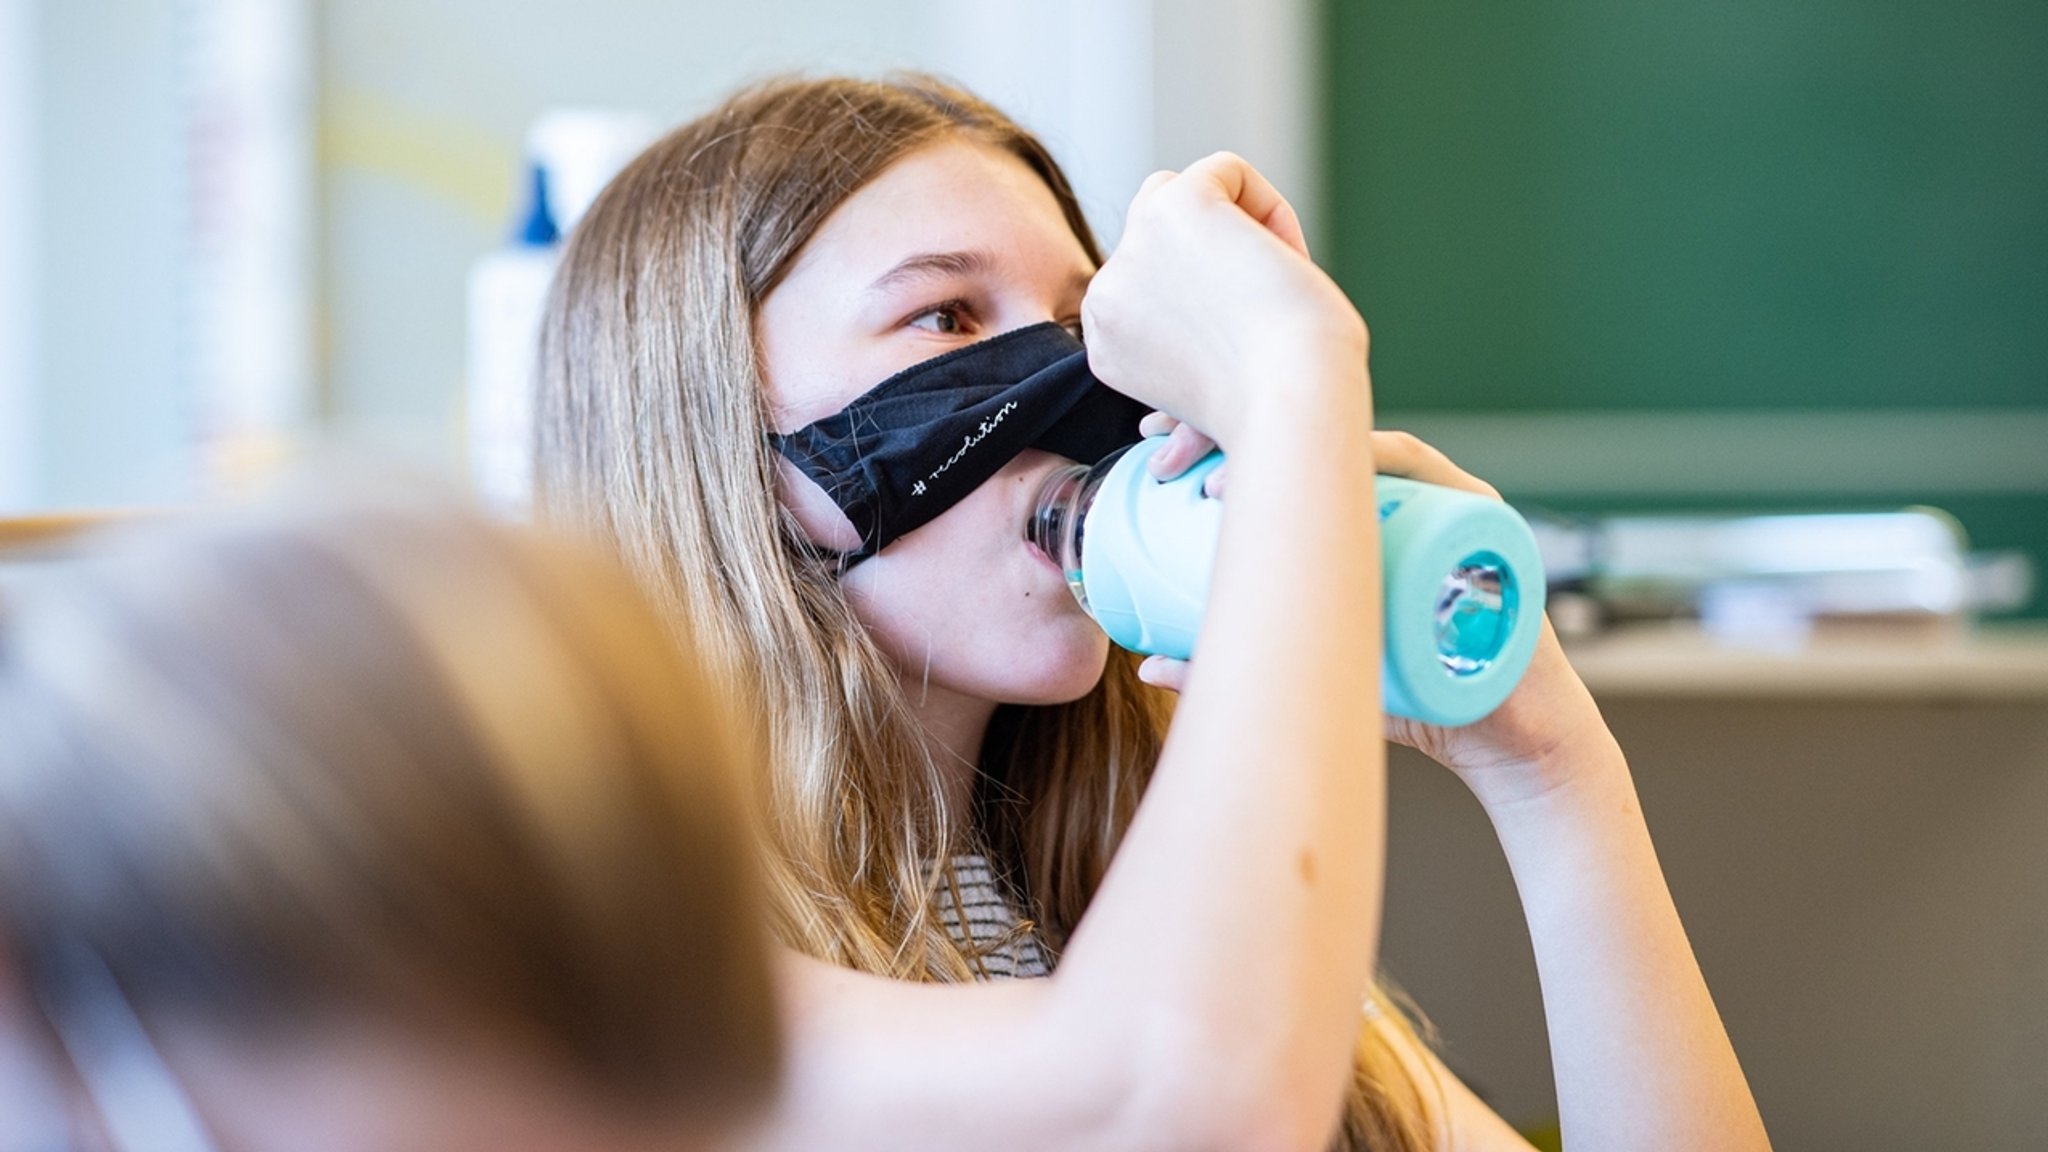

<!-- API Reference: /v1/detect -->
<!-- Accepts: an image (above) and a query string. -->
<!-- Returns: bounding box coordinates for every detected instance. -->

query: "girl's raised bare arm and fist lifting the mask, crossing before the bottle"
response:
[760,156,1384,1152]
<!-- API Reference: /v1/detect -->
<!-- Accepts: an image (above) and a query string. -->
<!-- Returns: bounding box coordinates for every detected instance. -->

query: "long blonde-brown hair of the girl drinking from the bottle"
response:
[537,76,1427,1150]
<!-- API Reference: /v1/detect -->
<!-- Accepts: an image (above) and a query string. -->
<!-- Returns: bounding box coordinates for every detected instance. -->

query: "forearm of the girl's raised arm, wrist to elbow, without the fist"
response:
[1061,354,1384,1139]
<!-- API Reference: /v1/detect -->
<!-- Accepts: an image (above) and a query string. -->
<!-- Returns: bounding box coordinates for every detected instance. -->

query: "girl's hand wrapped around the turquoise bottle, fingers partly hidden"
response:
[1139,412,1612,806]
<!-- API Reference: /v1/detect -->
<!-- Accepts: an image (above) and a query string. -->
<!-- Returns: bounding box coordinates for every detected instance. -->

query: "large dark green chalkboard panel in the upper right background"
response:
[1321,0,2048,410]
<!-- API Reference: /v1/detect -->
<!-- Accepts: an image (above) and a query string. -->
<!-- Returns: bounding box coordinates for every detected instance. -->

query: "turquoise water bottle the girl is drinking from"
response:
[1030,437,1544,726]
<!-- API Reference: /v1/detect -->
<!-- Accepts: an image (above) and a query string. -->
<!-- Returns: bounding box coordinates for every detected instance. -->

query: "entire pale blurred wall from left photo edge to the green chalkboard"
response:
[0,0,1315,498]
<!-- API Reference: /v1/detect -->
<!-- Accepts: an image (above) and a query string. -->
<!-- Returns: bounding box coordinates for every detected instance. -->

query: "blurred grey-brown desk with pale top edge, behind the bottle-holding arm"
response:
[1384,625,2048,1152]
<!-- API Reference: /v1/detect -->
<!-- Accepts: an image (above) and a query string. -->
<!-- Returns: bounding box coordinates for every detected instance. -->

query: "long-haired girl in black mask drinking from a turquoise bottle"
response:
[539,78,1763,1152]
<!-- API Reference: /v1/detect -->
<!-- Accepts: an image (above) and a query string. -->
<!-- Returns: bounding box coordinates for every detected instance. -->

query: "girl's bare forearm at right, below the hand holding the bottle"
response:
[1489,728,1767,1152]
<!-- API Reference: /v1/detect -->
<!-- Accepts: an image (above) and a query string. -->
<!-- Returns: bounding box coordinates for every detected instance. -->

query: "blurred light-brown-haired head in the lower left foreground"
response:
[0,485,778,1150]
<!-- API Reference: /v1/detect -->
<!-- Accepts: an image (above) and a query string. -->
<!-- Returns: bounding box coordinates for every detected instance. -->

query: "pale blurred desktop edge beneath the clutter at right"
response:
[1565,623,2048,703]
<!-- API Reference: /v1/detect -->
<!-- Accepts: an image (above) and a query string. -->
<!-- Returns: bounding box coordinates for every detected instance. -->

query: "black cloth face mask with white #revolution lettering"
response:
[768,324,1147,564]
